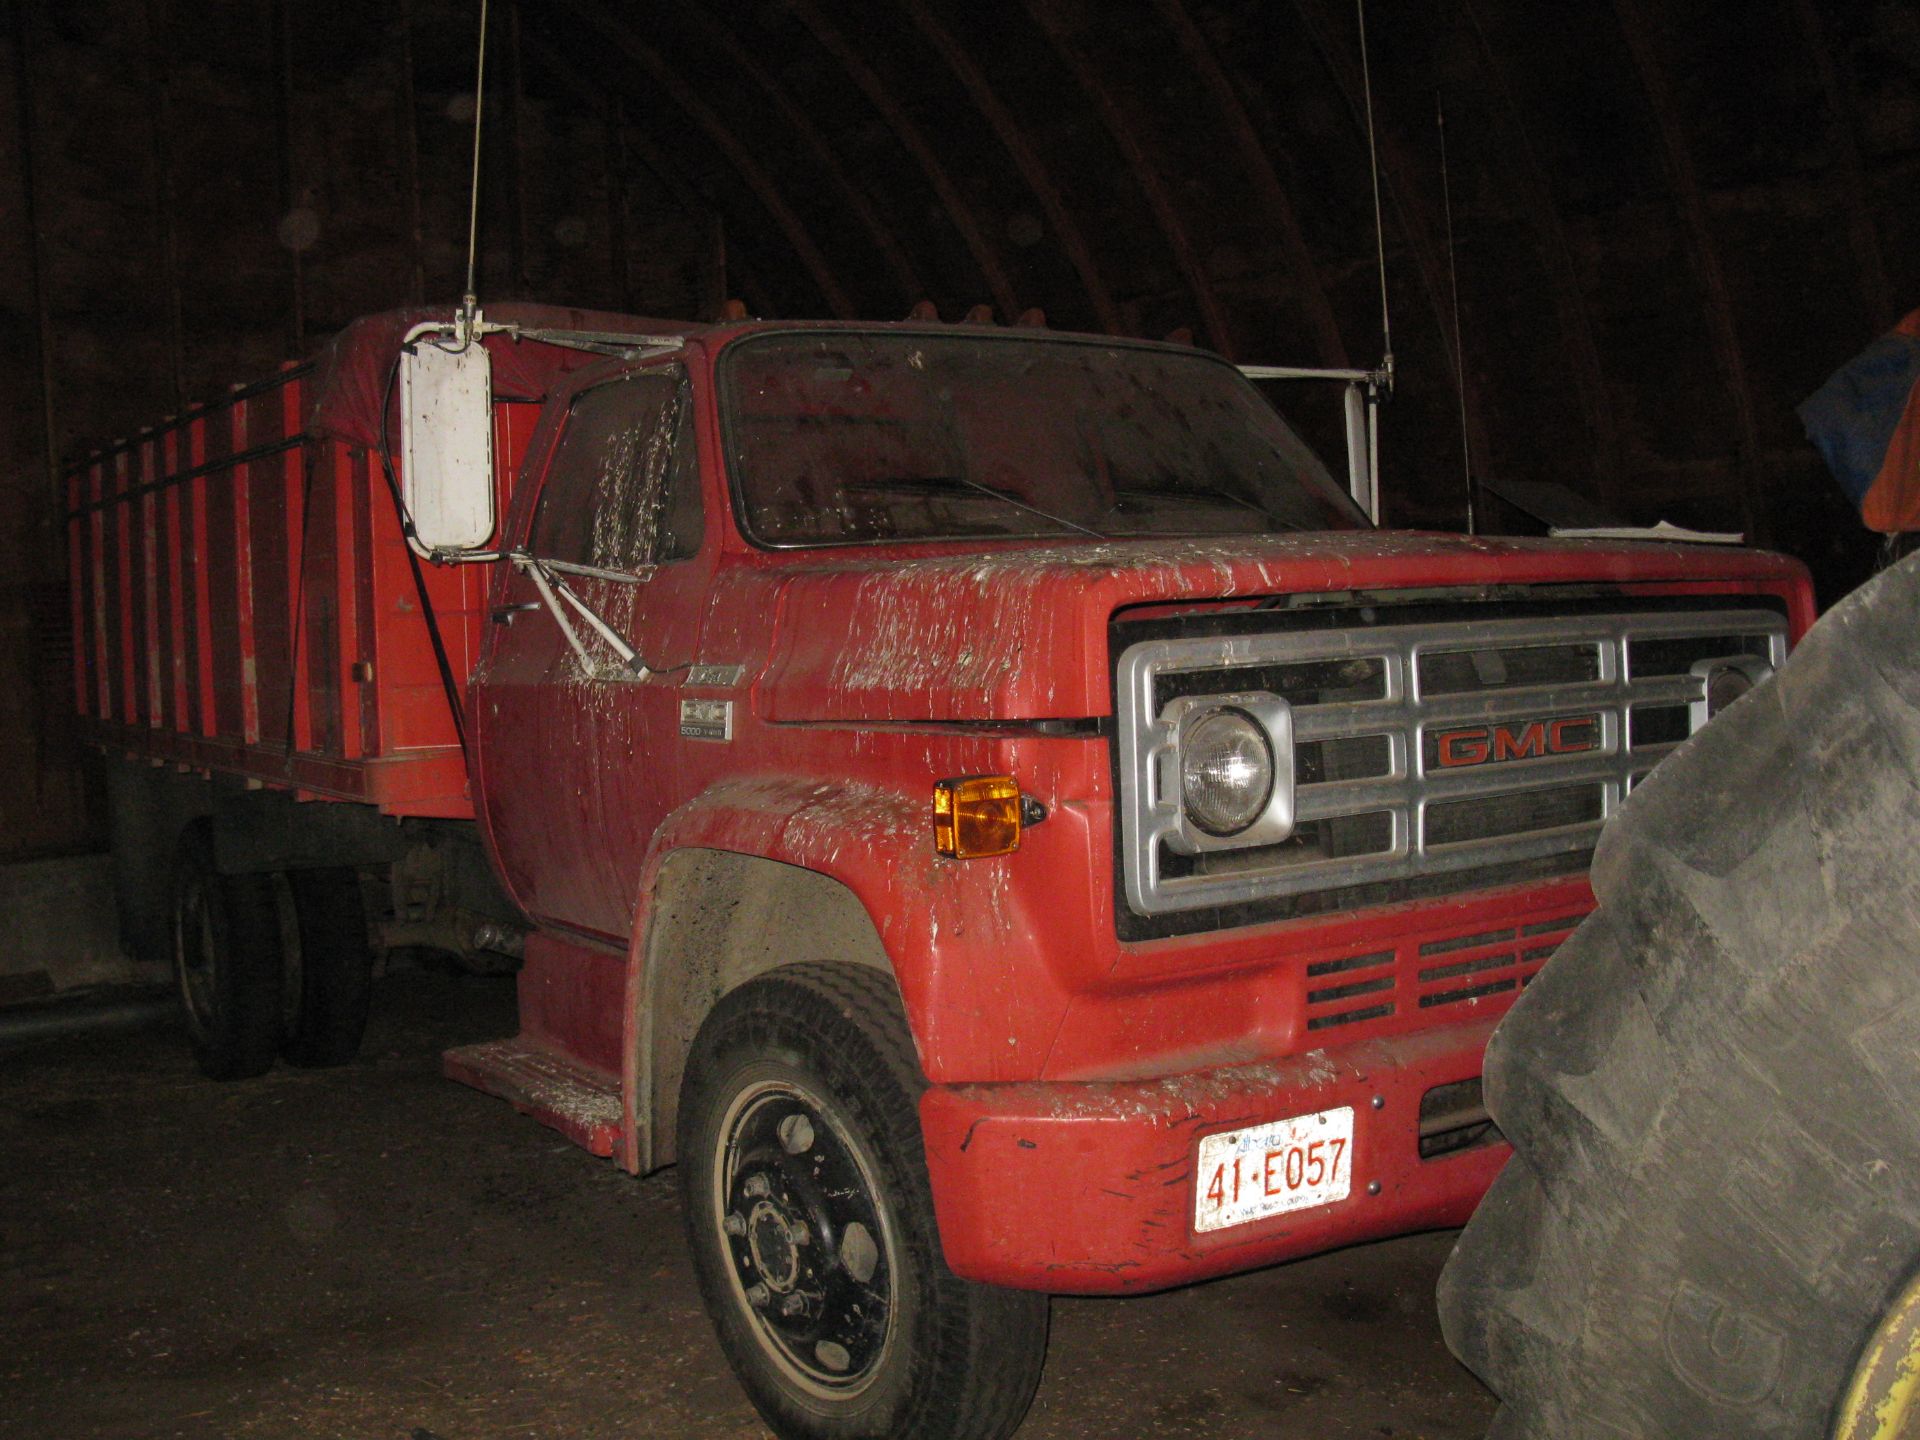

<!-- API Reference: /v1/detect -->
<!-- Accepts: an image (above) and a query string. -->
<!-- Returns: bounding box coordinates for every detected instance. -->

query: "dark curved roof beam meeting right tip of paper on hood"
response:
[1613,0,1761,540]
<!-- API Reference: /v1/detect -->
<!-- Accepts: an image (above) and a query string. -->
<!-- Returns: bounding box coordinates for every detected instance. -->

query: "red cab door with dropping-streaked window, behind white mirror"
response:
[474,363,712,941]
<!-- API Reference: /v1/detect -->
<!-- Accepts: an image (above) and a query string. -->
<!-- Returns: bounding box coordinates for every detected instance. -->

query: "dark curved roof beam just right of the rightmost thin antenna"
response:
[1461,0,1620,501]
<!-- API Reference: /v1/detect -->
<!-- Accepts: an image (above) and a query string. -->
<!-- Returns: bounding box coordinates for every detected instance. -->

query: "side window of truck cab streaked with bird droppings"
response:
[532,371,703,570]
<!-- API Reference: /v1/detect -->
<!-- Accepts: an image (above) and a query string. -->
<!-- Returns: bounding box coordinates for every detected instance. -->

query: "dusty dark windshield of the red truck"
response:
[720,332,1367,545]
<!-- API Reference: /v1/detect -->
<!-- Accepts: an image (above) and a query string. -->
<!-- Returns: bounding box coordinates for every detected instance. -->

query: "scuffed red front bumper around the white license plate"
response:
[920,1020,1507,1294]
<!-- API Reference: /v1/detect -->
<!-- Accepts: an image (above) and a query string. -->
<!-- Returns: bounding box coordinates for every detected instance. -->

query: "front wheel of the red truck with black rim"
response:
[678,964,1046,1440]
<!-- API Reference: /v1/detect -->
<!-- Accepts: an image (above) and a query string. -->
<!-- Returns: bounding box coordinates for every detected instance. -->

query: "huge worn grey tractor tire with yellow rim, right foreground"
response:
[1440,559,1920,1440]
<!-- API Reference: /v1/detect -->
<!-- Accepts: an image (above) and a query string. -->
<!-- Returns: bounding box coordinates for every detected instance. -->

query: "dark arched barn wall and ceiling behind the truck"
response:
[0,0,1920,852]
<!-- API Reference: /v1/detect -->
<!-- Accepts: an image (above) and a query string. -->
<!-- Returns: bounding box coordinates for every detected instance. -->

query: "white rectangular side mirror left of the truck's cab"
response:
[399,326,493,551]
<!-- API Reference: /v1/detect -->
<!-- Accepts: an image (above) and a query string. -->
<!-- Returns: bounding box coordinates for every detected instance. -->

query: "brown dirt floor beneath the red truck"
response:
[0,970,1492,1440]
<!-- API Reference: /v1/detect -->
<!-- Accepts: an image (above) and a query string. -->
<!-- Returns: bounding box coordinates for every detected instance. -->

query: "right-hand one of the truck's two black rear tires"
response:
[280,866,372,1068]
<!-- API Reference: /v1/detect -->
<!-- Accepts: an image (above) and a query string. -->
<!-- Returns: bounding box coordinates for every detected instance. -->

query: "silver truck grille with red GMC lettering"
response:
[1116,609,1786,917]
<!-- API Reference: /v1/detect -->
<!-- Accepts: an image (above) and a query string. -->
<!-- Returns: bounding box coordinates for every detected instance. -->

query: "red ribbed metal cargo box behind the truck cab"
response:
[67,347,503,816]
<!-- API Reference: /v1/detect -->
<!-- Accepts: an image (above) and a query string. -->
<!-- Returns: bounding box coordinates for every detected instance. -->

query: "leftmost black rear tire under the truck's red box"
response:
[171,820,282,1079]
